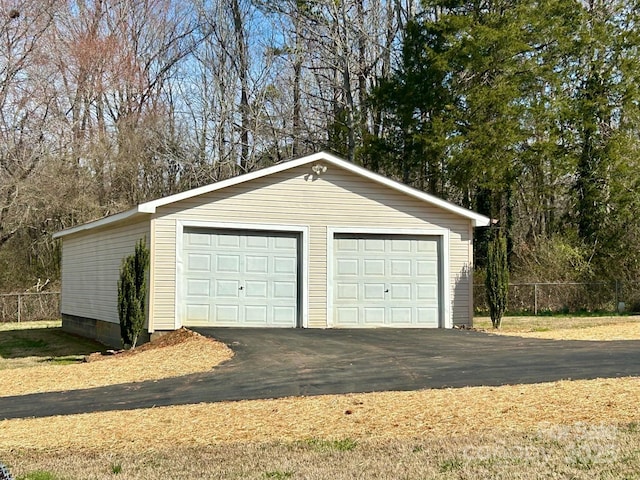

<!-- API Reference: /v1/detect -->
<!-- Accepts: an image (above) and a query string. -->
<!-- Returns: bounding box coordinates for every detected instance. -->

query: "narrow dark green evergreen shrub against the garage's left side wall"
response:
[118,239,149,348]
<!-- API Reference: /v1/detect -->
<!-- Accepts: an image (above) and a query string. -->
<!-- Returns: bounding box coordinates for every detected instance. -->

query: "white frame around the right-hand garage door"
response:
[327,227,453,328]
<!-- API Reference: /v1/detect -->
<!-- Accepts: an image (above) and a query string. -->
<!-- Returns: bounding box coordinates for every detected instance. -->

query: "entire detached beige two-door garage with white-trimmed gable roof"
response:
[54,153,489,345]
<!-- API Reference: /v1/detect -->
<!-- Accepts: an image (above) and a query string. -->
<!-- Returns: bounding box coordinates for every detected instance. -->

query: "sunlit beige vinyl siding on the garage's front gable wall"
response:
[153,165,471,329]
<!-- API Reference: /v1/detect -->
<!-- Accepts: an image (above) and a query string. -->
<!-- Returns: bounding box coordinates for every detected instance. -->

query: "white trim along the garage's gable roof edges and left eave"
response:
[53,152,490,238]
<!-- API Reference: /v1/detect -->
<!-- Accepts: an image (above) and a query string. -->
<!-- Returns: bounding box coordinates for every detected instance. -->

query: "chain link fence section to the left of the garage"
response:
[0,292,60,322]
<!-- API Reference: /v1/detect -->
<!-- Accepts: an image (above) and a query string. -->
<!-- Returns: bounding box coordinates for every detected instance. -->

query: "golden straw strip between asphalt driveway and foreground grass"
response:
[0,378,640,451]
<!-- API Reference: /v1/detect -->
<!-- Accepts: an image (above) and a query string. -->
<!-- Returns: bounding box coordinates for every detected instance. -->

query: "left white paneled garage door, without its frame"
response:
[181,230,298,327]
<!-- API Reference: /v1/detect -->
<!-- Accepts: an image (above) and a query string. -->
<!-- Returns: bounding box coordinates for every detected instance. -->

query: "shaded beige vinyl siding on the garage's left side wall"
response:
[61,221,149,323]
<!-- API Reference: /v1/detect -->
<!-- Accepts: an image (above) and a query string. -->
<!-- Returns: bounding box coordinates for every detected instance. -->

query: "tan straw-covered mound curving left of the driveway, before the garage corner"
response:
[0,330,233,396]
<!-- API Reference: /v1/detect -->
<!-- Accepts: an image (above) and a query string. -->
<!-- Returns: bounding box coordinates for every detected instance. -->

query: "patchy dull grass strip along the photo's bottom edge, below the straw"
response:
[5,424,640,480]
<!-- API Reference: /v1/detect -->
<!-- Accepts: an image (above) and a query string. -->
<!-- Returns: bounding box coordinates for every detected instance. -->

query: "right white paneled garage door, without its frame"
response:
[333,234,440,328]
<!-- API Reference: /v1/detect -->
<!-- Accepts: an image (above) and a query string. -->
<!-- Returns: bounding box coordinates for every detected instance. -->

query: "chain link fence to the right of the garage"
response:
[474,281,640,315]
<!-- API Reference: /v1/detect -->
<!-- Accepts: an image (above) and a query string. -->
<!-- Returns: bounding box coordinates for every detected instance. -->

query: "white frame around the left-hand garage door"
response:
[174,220,309,329]
